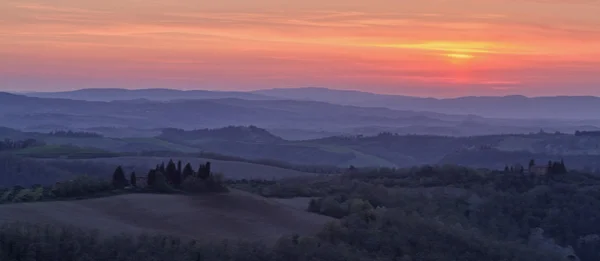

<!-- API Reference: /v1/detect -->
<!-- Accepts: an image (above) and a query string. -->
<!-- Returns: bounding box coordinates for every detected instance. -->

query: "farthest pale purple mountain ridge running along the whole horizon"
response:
[25,88,600,120]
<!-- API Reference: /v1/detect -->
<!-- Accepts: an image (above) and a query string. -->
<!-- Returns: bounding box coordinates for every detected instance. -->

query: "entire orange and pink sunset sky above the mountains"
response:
[0,0,600,97]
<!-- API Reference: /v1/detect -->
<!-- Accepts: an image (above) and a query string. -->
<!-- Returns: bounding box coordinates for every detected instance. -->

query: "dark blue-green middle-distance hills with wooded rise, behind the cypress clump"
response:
[3,126,600,171]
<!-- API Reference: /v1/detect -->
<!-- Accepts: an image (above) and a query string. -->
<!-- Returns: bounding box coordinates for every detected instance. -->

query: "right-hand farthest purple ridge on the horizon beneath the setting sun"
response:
[253,88,600,122]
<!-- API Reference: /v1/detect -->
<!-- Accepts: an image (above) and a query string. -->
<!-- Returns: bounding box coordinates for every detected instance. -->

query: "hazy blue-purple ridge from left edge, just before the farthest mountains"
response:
[0,90,600,139]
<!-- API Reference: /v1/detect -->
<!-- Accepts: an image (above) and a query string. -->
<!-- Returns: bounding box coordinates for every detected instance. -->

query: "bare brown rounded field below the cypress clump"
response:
[0,190,331,243]
